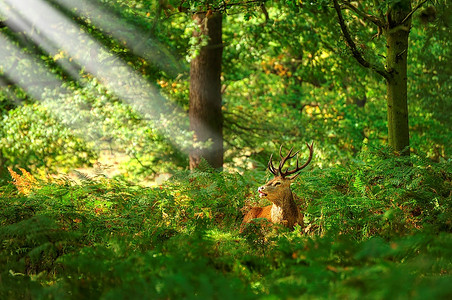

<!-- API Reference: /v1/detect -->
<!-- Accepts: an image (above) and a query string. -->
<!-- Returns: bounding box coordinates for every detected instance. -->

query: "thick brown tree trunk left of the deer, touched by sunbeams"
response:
[189,13,223,170]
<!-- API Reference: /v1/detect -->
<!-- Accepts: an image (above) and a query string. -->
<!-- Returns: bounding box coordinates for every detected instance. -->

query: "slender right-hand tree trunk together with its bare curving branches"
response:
[333,0,414,155]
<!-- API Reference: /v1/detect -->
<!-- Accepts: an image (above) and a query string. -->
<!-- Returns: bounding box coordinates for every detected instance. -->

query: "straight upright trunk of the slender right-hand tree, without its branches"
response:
[385,0,411,155]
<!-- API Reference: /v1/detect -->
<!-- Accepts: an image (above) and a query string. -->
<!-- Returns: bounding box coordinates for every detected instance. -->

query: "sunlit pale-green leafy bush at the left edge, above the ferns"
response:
[0,105,96,171]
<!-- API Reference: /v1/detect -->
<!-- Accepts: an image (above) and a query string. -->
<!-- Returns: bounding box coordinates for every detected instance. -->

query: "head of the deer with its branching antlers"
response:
[258,143,314,206]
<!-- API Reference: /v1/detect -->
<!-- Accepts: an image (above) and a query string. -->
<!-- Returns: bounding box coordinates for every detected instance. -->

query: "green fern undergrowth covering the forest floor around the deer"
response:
[0,151,452,299]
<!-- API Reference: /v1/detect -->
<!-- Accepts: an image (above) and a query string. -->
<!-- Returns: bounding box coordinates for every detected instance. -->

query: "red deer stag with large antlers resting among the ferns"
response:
[240,143,314,232]
